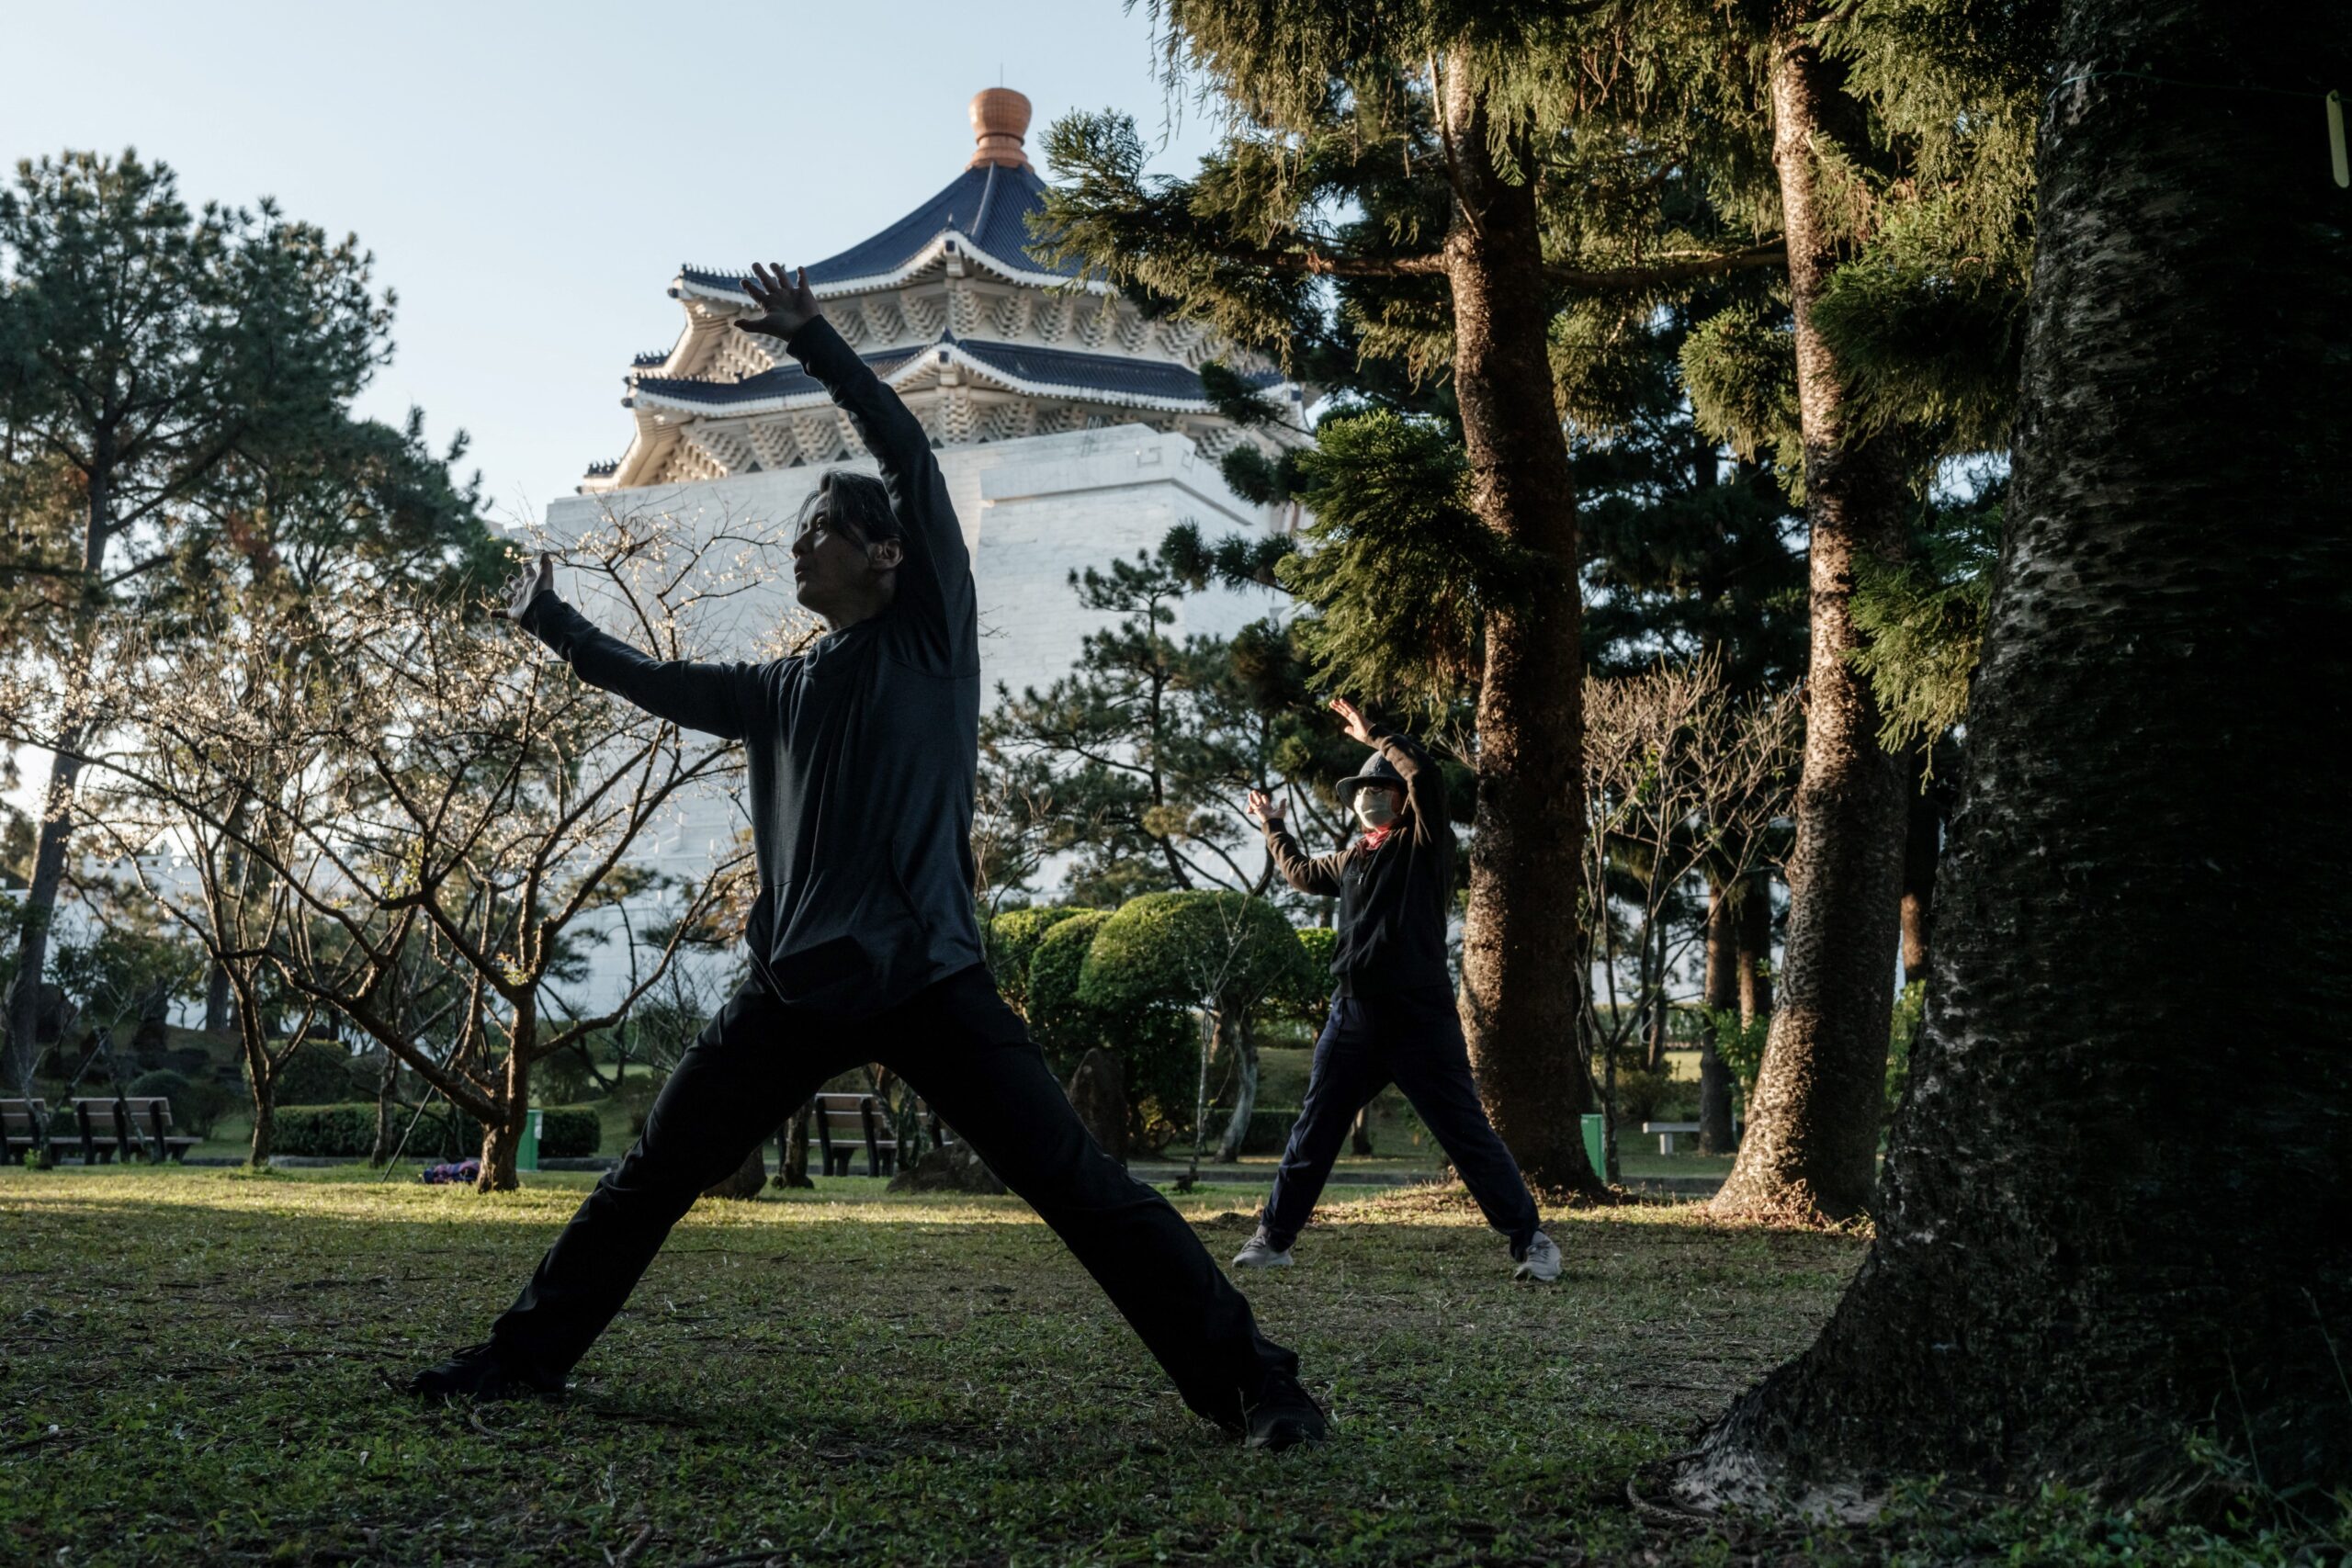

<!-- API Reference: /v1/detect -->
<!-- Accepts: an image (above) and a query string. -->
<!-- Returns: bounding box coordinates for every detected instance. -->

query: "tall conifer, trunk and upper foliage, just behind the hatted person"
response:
[1046,0,1778,1190]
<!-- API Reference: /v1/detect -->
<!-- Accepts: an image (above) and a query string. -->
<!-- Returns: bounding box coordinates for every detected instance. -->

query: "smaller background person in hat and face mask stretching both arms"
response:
[1232,698,1559,1281]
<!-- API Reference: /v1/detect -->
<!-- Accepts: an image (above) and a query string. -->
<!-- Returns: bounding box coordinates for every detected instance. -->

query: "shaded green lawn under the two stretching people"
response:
[0,1166,2314,1565]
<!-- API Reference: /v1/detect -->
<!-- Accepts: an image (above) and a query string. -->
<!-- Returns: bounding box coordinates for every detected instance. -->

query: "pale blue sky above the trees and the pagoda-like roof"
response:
[0,0,1209,520]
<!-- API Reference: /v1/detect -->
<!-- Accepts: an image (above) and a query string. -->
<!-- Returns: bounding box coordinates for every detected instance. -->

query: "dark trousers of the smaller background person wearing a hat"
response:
[1259,987,1541,1258]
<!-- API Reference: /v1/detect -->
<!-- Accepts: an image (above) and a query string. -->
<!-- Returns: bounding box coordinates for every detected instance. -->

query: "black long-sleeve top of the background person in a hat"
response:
[1265,731,1453,997]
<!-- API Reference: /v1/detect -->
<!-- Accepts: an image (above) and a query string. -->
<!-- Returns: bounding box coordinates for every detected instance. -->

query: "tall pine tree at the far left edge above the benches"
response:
[0,152,433,1077]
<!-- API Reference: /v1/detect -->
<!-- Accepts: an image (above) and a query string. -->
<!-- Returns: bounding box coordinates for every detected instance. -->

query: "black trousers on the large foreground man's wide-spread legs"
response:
[492,966,1298,1425]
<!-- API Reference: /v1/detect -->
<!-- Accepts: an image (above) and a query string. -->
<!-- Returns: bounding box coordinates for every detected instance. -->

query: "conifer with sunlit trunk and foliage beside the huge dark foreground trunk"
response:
[1684,0,2049,1220]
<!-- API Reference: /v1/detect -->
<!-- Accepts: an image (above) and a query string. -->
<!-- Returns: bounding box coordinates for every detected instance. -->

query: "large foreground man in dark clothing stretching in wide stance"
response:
[412,268,1324,1448]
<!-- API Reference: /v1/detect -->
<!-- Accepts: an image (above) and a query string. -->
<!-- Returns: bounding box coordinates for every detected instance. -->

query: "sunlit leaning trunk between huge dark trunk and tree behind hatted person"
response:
[1714,28,1905,1220]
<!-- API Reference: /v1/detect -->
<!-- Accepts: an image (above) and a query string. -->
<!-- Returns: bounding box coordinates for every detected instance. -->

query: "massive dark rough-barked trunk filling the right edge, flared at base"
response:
[1684,0,2352,1506]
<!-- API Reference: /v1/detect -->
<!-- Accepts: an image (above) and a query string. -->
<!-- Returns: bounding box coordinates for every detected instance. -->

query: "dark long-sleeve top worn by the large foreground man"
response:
[522,317,981,1018]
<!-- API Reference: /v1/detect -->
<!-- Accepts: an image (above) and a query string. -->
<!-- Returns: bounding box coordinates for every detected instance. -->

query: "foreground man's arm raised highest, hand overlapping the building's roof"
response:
[736,265,981,660]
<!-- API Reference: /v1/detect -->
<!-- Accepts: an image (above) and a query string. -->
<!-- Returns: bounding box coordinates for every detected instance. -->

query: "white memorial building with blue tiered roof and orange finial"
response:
[546,87,1306,989]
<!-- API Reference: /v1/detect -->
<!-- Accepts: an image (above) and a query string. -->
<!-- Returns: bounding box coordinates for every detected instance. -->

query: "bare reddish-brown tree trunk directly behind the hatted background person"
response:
[1442,58,1600,1194]
